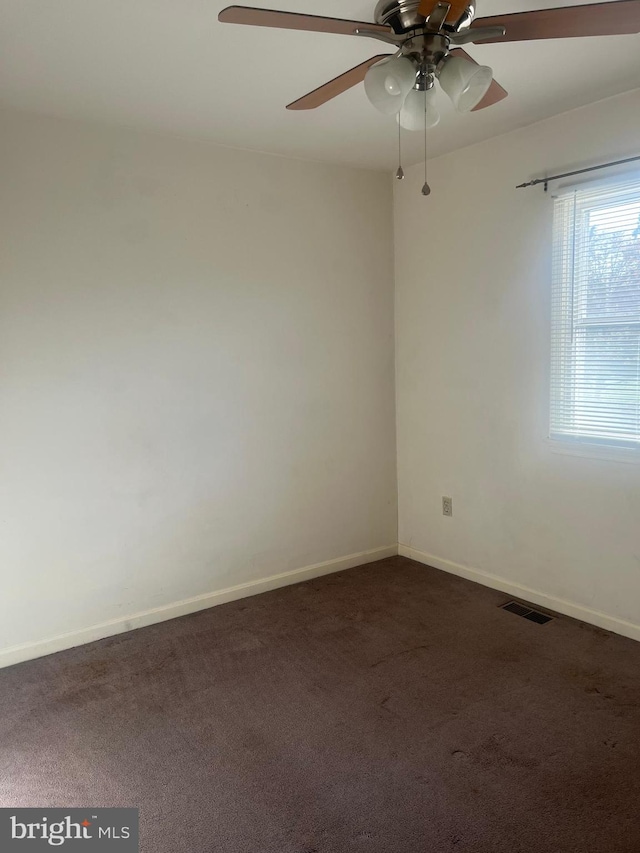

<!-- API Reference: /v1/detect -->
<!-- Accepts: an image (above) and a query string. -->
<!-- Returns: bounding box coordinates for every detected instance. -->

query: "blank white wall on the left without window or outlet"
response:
[0,112,397,663]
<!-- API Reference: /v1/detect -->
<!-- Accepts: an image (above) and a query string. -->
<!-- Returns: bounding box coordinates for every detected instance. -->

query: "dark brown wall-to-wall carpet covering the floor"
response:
[0,557,640,853]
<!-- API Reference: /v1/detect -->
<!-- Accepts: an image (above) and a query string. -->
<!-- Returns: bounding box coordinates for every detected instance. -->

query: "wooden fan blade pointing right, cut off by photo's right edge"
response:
[471,0,640,44]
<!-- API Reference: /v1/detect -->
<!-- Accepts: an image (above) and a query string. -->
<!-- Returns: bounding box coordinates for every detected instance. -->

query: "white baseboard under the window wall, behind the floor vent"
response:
[398,545,640,640]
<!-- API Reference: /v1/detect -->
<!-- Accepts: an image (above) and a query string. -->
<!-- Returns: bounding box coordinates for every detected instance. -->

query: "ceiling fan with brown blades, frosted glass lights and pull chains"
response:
[218,0,640,188]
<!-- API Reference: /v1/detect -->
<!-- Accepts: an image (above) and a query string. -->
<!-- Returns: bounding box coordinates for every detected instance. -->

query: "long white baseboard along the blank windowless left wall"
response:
[0,545,398,669]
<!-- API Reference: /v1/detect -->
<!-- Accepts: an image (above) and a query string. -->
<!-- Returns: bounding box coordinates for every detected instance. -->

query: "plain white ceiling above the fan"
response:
[0,0,640,169]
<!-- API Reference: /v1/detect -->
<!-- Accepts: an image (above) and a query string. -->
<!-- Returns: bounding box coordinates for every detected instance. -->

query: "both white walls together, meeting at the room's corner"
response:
[5,86,640,665]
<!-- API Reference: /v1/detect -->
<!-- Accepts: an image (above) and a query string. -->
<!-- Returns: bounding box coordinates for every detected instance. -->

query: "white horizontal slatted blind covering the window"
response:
[550,176,640,448]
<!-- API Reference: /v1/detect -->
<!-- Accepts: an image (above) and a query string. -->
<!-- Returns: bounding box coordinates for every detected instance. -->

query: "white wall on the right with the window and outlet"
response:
[395,91,640,639]
